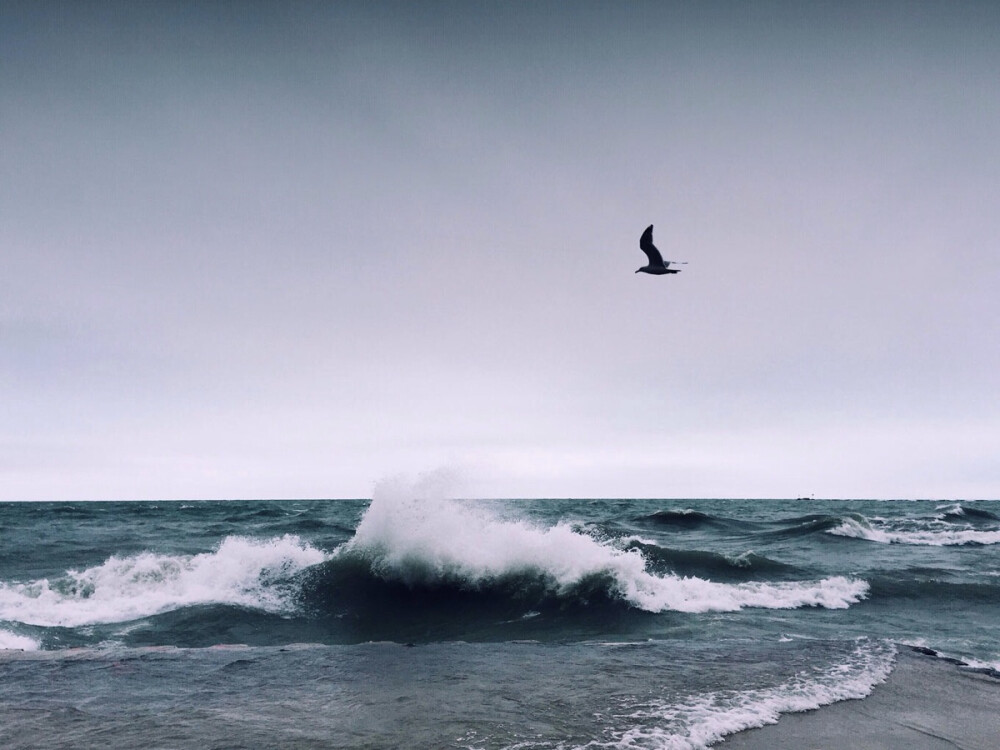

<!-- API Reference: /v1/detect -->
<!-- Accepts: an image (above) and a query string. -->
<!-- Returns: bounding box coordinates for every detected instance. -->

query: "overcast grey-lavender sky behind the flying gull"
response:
[0,1,1000,500]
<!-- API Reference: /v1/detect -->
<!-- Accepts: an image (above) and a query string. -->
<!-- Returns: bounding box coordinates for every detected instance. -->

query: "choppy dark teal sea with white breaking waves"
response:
[0,483,1000,750]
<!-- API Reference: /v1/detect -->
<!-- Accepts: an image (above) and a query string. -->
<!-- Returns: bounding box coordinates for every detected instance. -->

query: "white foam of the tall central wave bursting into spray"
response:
[338,483,868,612]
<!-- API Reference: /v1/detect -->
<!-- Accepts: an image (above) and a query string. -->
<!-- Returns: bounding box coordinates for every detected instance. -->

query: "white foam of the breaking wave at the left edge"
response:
[0,535,326,627]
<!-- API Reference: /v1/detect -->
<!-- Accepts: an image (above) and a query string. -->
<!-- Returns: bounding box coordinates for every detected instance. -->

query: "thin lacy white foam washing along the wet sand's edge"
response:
[603,640,896,750]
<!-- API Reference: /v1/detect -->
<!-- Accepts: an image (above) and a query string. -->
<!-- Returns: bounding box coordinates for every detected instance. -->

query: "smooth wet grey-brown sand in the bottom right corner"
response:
[716,646,1000,750]
